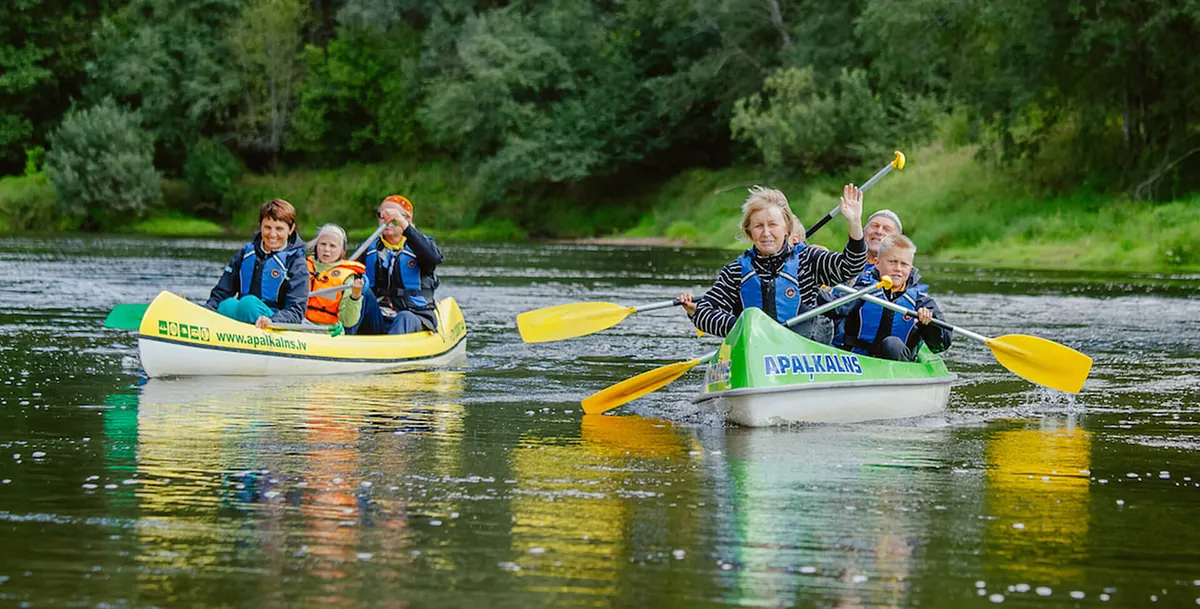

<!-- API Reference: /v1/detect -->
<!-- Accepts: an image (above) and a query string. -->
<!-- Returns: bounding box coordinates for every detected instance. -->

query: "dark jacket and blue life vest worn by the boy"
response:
[833,269,954,355]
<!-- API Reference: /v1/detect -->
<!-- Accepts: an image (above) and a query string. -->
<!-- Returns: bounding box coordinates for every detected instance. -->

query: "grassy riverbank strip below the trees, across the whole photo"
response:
[0,145,1200,271]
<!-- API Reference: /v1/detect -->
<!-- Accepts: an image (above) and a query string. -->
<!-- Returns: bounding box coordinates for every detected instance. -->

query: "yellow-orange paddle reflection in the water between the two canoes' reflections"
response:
[508,415,703,599]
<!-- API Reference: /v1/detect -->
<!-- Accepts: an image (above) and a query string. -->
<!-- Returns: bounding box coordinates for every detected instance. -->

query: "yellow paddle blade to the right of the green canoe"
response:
[988,334,1092,393]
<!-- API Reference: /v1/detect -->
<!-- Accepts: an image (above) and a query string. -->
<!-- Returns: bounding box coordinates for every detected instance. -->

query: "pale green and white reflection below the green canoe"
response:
[709,426,947,607]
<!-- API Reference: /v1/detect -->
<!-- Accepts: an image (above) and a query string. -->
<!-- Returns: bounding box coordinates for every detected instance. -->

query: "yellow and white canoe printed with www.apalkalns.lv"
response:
[138,291,467,378]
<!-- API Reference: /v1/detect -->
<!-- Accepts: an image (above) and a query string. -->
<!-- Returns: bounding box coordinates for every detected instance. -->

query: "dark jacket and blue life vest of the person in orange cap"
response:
[362,224,443,330]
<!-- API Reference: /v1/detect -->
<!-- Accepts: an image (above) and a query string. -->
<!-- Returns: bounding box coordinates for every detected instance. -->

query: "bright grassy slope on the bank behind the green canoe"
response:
[620,146,1200,271]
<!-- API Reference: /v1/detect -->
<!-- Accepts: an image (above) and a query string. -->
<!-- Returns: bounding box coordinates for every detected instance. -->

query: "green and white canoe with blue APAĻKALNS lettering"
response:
[692,308,958,427]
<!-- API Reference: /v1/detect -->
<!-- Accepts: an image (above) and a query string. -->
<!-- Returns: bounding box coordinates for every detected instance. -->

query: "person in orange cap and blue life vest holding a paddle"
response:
[358,194,442,334]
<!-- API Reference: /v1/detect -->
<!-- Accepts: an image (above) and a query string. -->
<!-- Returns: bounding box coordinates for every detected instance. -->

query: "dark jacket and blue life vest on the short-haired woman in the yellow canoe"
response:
[204,231,308,324]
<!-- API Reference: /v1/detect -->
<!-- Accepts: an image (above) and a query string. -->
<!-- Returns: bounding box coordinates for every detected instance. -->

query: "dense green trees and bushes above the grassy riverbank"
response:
[0,0,1200,228]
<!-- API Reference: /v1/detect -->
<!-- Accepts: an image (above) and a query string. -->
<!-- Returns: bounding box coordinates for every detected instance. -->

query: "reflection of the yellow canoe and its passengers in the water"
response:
[110,370,463,595]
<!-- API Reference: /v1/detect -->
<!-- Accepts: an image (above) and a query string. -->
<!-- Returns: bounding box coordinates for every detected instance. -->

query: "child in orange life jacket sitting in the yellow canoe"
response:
[305,224,366,334]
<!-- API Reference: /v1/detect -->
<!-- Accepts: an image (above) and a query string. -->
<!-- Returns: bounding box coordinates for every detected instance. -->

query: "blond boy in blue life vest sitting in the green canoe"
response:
[836,234,954,362]
